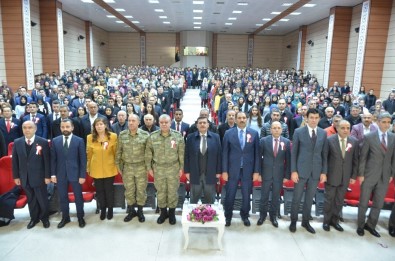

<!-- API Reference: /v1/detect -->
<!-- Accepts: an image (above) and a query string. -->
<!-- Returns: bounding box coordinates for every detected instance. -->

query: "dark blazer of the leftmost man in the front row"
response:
[12,135,51,188]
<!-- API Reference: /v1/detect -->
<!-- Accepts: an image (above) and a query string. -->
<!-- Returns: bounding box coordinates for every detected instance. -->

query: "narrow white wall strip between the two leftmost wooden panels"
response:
[30,0,43,74]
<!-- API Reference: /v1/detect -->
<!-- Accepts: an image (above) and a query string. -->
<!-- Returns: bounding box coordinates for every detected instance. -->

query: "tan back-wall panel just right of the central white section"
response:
[217,34,248,67]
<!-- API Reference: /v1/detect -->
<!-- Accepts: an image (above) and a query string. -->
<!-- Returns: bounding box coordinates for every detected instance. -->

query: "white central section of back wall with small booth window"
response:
[182,31,213,67]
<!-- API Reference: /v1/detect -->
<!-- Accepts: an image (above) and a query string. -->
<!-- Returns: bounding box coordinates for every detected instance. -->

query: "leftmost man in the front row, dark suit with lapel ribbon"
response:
[12,120,51,229]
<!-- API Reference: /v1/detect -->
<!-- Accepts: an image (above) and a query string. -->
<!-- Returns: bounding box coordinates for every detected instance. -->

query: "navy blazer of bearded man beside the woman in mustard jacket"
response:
[51,135,87,182]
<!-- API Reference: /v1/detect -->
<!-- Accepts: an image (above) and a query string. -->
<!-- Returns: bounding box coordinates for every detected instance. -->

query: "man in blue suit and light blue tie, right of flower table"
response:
[222,112,260,226]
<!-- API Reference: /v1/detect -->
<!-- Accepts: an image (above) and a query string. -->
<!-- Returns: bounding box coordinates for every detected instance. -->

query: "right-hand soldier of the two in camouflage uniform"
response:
[145,114,185,225]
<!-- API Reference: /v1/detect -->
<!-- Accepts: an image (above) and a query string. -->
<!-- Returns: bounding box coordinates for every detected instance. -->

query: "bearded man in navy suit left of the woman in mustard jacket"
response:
[51,119,86,228]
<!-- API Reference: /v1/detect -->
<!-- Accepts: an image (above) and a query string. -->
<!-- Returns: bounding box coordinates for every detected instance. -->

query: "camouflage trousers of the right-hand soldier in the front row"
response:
[154,166,180,208]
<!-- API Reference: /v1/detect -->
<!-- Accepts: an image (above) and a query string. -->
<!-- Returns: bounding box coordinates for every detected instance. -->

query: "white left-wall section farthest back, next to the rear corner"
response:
[91,25,110,68]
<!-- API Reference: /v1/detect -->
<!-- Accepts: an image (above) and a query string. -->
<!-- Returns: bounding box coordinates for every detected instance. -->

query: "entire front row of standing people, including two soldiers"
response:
[13,109,395,237]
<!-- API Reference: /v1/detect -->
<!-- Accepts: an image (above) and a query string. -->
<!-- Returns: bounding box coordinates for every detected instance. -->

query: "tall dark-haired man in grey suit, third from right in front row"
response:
[289,109,328,234]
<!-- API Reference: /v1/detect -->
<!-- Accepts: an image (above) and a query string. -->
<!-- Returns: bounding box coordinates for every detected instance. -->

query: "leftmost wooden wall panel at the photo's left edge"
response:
[1,1,26,91]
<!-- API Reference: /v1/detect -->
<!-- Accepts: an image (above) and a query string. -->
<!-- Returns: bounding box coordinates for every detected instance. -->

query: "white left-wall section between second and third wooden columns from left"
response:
[63,12,87,70]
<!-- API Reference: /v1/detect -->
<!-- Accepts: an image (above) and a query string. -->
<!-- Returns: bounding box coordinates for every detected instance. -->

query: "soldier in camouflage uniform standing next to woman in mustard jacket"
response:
[115,114,149,222]
